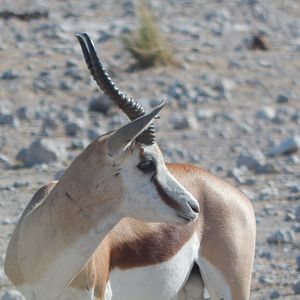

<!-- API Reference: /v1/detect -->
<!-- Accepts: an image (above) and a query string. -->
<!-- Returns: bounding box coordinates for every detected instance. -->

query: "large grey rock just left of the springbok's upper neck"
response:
[17,139,66,167]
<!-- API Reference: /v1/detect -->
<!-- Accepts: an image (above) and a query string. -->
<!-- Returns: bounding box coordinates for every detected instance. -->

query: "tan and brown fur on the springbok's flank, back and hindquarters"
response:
[72,164,255,300]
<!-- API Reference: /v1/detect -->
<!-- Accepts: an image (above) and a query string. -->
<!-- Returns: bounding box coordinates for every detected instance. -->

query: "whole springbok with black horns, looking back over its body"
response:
[5,34,256,300]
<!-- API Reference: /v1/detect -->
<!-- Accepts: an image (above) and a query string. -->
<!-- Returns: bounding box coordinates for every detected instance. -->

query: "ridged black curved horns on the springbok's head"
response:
[76,33,155,145]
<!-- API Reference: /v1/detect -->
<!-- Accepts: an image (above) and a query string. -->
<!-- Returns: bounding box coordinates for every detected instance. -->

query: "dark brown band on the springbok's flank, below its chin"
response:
[110,220,196,270]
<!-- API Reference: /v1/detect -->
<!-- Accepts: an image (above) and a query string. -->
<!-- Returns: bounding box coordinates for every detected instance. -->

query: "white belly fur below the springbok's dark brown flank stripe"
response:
[109,234,200,300]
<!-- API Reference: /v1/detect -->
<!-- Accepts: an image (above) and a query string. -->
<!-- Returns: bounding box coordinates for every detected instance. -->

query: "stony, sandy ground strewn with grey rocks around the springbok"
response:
[0,0,300,300]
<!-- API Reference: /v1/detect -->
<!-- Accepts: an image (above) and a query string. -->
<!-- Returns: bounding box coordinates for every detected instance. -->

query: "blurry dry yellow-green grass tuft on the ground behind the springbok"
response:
[124,1,177,68]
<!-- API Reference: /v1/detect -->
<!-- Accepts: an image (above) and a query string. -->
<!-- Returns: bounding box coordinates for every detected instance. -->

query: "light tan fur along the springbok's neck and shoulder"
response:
[5,140,122,285]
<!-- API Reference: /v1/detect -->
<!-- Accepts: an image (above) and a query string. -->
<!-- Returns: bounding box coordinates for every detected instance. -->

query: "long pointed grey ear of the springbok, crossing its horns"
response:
[107,101,166,155]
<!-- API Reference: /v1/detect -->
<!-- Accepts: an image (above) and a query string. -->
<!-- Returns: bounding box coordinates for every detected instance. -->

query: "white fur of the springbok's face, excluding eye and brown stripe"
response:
[120,144,199,224]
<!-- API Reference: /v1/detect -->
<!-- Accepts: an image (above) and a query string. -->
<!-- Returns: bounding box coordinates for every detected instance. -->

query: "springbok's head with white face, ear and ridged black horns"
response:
[76,33,199,224]
